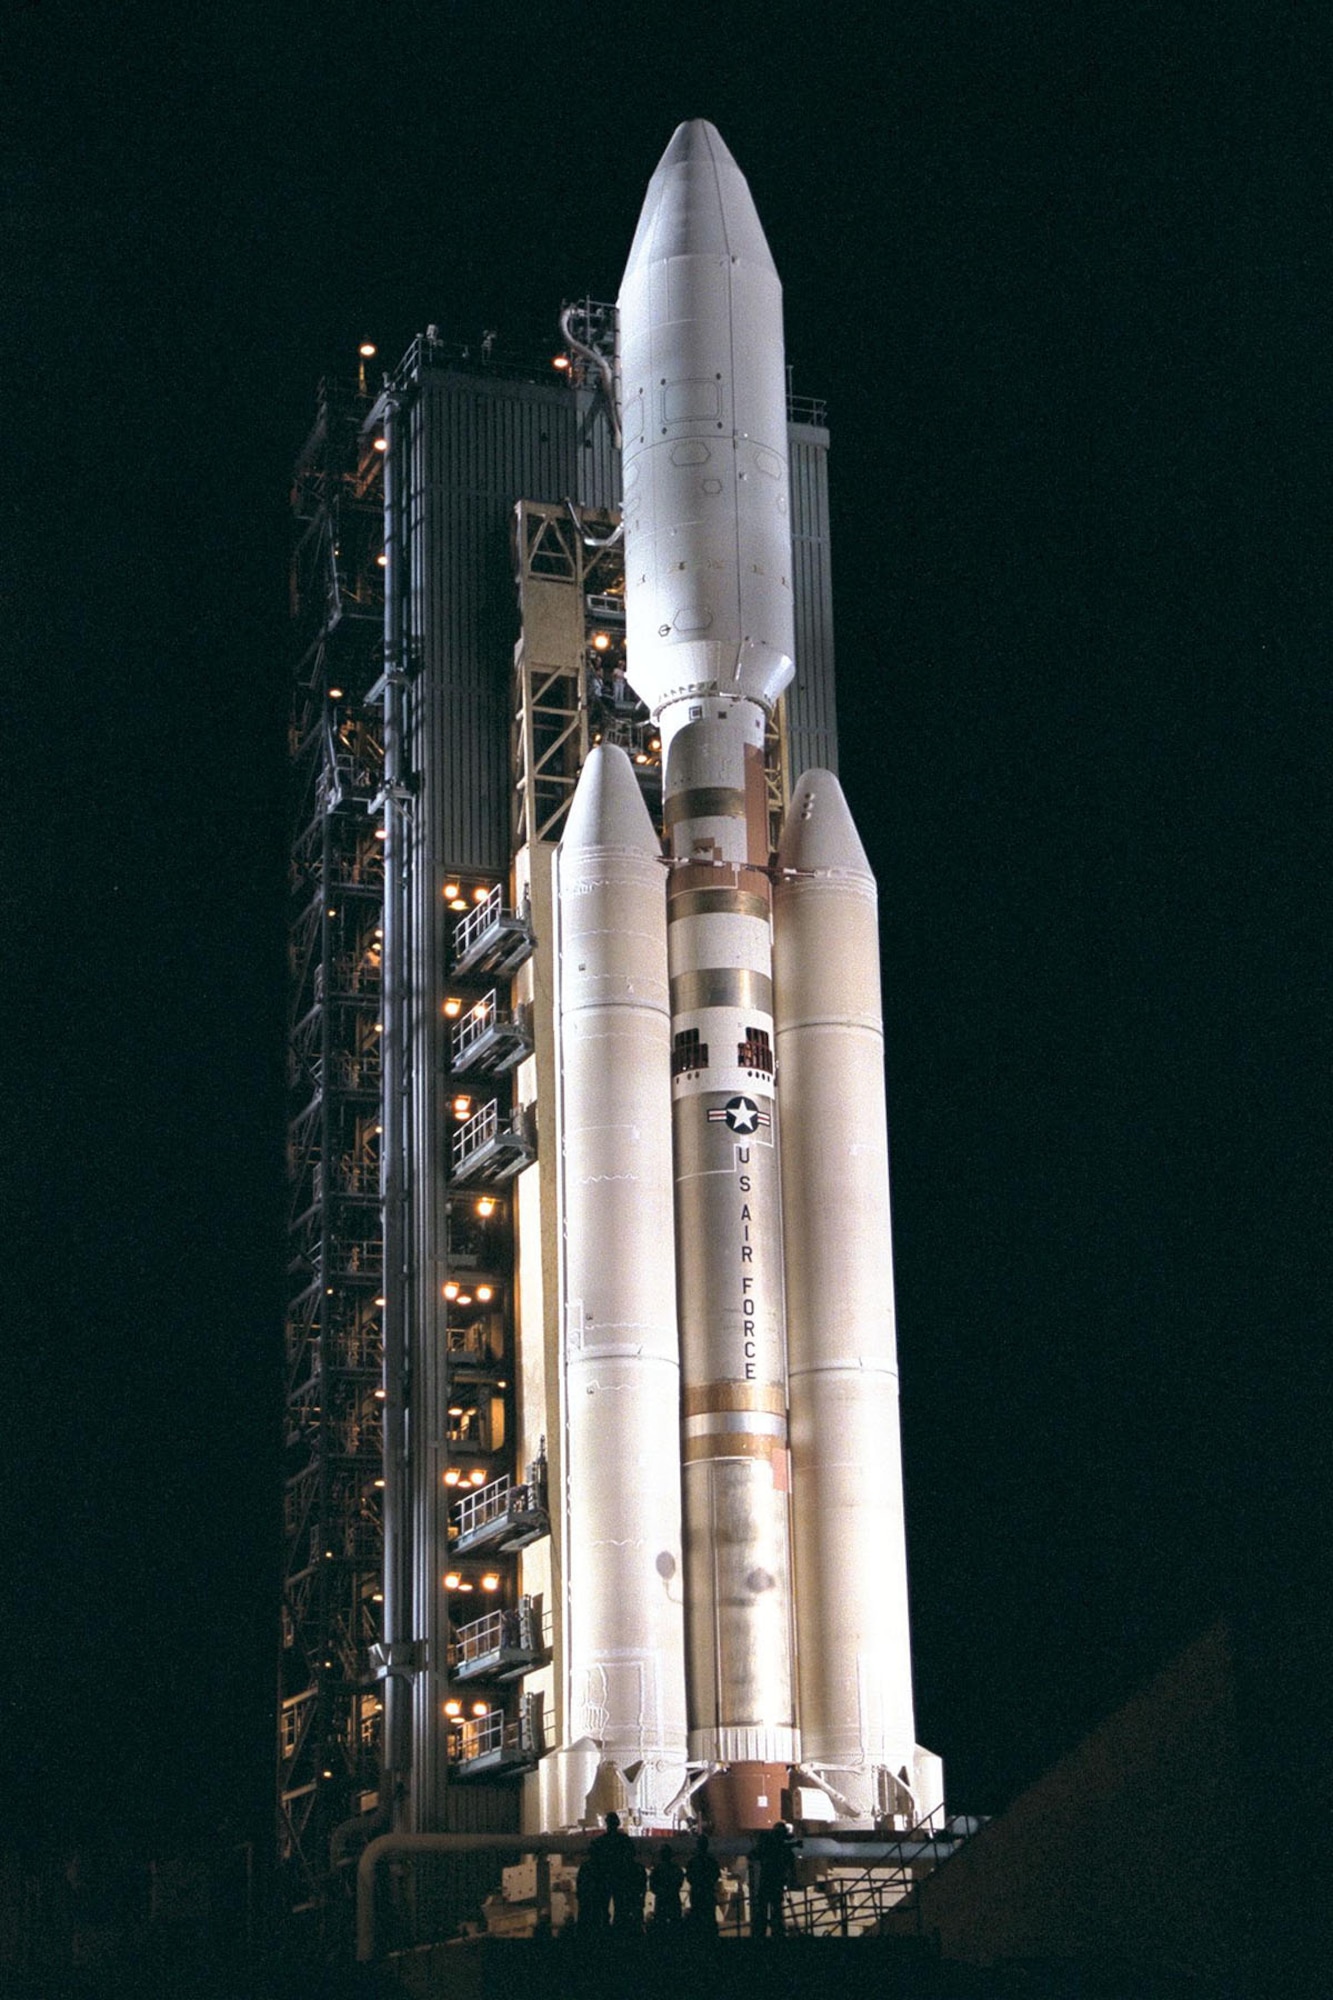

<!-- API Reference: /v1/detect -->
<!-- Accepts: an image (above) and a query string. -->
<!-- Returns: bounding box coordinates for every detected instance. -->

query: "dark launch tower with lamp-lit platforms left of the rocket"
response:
[278,336,808,1926]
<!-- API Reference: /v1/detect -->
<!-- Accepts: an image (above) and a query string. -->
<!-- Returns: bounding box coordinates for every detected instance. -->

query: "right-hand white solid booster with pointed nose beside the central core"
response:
[773,770,941,1820]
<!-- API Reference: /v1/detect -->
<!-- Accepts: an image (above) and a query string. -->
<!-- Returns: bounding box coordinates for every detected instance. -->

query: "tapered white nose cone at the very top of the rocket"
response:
[624,118,773,280]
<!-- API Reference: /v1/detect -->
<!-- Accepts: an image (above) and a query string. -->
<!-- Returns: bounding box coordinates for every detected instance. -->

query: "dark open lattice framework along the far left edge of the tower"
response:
[278,382,384,1906]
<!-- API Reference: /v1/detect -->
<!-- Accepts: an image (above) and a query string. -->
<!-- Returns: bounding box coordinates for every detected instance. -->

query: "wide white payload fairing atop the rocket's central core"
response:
[620,118,795,736]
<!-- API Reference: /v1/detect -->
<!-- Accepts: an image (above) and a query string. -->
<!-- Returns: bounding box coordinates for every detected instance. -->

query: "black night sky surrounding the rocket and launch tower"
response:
[0,0,1331,1872]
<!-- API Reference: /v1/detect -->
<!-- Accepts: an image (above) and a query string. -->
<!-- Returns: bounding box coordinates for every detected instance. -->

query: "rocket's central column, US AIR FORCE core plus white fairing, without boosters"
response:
[620,120,799,1776]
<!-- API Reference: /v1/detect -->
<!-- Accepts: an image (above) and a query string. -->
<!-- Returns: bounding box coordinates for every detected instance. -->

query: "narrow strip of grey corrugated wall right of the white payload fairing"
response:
[787,424,839,782]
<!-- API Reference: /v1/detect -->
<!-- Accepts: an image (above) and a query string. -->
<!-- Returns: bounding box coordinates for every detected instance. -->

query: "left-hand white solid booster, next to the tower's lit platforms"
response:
[550,746,687,1824]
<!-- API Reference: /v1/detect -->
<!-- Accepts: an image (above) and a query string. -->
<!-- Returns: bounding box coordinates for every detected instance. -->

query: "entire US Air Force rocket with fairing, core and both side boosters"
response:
[556,120,941,1830]
